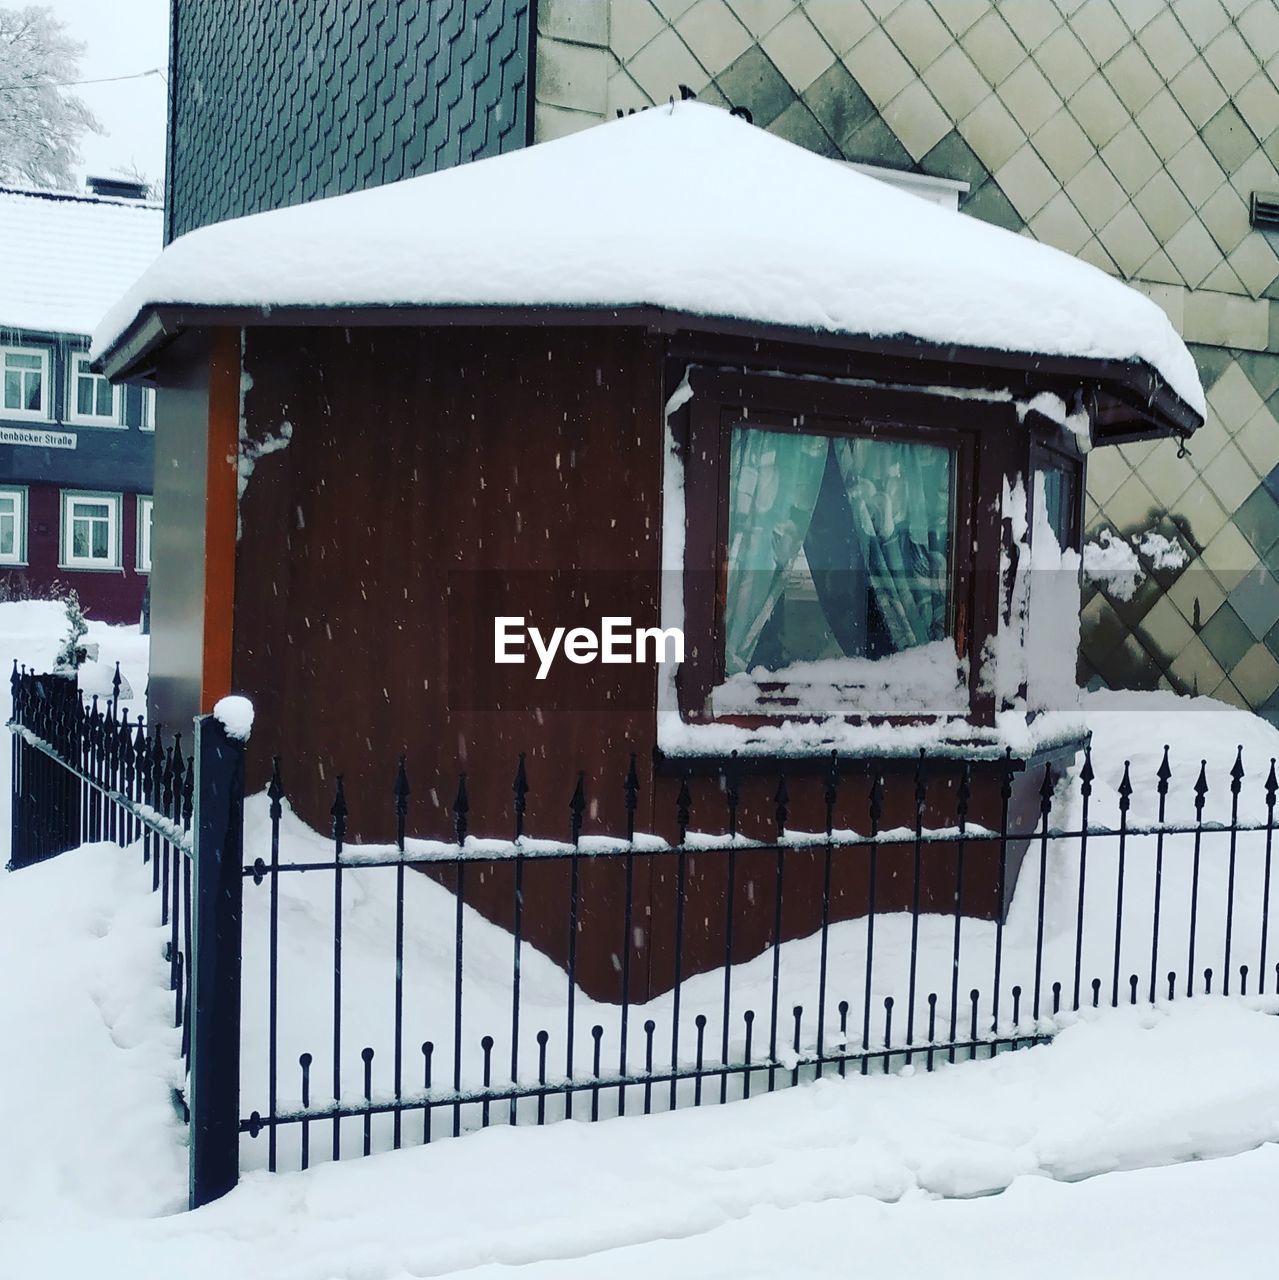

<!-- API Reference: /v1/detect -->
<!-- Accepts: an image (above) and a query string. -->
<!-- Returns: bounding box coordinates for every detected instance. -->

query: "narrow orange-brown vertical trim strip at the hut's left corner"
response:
[200,329,239,712]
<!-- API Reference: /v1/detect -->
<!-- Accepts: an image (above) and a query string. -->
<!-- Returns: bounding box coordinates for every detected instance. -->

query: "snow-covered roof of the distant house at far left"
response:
[0,187,164,335]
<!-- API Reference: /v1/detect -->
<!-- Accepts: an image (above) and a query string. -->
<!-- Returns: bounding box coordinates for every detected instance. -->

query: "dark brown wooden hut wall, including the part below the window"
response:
[233,328,1080,998]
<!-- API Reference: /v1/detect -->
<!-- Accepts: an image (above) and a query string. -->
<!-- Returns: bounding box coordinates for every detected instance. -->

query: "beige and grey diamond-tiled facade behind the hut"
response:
[536,0,1279,719]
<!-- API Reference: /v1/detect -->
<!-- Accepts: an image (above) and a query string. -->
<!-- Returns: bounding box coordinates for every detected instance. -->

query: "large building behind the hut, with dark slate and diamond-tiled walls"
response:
[169,0,1279,716]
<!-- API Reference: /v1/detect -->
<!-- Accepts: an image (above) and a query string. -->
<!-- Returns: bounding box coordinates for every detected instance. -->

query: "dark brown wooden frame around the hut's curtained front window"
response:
[681,371,988,727]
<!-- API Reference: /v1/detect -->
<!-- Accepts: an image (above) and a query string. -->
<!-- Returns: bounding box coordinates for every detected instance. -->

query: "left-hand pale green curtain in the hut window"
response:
[725,428,830,676]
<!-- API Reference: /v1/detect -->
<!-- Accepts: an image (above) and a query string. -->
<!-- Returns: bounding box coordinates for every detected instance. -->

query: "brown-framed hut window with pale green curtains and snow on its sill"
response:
[681,369,978,727]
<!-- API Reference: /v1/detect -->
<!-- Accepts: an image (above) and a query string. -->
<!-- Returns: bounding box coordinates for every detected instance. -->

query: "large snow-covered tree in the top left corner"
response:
[0,5,102,188]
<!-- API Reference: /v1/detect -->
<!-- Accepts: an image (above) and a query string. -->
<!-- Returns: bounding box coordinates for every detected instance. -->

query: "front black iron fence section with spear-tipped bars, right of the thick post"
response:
[241,749,1279,1169]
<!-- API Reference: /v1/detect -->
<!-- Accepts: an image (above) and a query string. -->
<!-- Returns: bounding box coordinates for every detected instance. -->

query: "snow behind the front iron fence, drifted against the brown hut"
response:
[233,694,1279,1169]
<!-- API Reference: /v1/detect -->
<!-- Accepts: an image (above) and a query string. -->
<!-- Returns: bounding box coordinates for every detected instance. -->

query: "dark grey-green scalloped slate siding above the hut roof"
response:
[166,0,535,239]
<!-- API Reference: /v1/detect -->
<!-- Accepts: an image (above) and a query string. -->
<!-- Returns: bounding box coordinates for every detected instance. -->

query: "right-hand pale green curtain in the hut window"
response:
[833,439,951,653]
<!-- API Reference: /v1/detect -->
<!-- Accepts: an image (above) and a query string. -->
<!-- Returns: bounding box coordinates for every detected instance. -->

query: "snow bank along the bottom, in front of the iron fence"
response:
[0,1004,1279,1280]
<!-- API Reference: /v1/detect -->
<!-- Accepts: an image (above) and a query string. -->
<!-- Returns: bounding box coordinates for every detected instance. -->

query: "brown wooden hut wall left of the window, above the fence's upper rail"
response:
[234,329,662,840]
